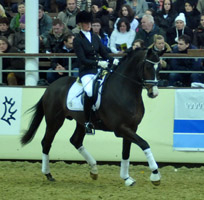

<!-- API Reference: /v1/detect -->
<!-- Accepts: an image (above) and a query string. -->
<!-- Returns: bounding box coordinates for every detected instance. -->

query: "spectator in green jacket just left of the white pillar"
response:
[10,2,25,31]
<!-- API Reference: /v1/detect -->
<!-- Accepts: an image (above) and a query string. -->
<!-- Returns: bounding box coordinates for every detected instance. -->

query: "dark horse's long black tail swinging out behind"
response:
[20,98,44,145]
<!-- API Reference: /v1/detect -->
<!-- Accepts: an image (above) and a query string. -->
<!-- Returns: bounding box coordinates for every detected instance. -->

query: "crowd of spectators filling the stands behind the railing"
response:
[0,0,204,87]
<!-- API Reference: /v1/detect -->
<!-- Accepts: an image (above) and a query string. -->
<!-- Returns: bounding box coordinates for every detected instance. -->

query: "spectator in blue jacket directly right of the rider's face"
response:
[91,19,111,53]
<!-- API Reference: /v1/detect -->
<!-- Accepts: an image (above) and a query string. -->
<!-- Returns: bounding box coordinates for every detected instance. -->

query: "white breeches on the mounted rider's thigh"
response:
[81,74,95,97]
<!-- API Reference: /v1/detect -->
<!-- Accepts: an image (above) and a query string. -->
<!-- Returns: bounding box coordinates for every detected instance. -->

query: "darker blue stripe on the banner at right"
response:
[174,120,204,133]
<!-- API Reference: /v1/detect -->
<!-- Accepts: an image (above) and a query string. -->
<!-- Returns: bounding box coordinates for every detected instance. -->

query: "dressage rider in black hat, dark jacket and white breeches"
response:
[74,11,119,134]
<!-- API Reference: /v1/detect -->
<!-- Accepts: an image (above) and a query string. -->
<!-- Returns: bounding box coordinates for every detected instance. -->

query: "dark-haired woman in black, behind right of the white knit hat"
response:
[184,0,200,31]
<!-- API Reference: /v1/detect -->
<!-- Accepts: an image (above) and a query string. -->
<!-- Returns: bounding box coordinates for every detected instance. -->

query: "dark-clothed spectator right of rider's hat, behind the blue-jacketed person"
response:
[91,0,111,35]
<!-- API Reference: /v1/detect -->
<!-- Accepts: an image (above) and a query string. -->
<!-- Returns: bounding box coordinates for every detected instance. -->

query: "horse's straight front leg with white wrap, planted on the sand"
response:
[120,139,136,186]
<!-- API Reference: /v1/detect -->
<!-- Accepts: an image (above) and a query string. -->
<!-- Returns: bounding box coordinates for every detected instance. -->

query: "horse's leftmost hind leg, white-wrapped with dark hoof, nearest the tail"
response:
[41,117,64,181]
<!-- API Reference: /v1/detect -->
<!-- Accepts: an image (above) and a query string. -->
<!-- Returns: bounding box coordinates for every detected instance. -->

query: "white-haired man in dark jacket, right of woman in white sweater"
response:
[135,14,165,47]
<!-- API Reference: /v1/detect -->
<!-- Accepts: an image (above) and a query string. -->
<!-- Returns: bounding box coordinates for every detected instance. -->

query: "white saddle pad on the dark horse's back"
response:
[67,78,104,111]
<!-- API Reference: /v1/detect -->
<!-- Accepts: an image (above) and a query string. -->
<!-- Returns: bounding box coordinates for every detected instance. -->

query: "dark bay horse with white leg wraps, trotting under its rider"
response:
[21,49,161,186]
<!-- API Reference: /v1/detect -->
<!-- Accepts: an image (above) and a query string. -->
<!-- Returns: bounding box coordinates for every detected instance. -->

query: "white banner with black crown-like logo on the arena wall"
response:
[0,88,22,135]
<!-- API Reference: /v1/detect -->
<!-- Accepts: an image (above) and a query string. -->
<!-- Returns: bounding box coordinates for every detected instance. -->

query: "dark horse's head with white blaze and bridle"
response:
[143,49,160,98]
